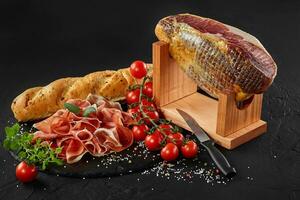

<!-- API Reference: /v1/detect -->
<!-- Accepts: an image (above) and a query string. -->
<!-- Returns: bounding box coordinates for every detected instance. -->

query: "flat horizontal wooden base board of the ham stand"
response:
[161,93,267,149]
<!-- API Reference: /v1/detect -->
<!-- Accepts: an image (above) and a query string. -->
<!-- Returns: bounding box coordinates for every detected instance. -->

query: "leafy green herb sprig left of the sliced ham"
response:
[3,123,63,170]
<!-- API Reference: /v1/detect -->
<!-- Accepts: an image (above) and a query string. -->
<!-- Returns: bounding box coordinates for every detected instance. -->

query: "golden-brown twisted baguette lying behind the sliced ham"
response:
[11,68,133,122]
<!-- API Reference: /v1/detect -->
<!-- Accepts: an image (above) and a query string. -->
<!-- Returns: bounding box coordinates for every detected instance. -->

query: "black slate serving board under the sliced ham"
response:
[10,123,161,178]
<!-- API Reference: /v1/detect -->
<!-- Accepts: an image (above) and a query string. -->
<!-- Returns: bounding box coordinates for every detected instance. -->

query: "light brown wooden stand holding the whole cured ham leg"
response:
[153,41,267,149]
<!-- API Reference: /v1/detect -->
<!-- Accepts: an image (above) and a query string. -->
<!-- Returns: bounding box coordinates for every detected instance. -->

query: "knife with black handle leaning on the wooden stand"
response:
[176,109,236,178]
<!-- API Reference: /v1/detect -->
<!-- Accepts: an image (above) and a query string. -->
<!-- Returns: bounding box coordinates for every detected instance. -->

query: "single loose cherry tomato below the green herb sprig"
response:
[16,161,37,183]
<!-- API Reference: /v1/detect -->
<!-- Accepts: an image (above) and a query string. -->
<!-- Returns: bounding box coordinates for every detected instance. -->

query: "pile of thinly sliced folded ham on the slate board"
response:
[33,95,133,164]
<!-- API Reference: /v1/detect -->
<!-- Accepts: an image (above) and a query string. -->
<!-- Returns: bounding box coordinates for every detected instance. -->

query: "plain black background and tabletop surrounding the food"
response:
[0,0,300,200]
